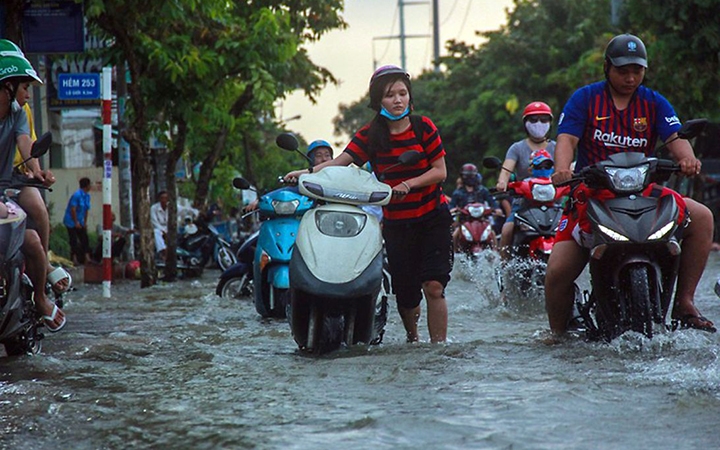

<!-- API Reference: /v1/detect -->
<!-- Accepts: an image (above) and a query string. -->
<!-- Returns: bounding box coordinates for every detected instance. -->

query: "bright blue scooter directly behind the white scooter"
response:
[233,178,314,318]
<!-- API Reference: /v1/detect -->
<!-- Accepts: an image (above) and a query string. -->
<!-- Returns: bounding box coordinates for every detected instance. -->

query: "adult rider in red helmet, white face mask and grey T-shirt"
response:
[495,101,555,259]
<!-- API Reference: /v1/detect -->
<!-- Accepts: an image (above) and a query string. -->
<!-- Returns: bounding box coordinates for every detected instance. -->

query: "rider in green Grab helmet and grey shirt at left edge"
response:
[0,51,66,332]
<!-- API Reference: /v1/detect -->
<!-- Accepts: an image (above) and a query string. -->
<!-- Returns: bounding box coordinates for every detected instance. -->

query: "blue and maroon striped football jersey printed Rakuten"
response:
[558,81,680,173]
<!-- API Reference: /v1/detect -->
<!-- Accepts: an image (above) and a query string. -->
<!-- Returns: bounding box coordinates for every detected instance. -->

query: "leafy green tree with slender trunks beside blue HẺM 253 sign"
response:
[85,0,343,286]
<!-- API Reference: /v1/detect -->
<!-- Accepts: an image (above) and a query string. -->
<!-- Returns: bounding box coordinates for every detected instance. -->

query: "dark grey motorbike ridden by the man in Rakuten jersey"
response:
[568,119,707,341]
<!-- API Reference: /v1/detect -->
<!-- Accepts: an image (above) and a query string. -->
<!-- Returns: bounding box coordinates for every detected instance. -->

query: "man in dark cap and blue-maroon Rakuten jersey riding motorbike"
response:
[545,34,716,334]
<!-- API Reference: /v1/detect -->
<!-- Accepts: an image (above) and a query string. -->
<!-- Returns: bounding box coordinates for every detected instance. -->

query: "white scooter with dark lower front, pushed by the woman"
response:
[277,134,422,354]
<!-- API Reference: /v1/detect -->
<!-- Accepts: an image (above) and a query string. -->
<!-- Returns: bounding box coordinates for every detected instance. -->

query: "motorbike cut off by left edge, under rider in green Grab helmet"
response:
[0,133,56,355]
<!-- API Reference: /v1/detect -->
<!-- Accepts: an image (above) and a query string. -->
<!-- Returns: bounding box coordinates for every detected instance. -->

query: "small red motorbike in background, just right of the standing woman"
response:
[456,203,497,257]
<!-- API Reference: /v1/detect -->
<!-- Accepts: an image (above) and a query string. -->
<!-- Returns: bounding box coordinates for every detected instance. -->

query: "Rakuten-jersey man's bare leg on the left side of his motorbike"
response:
[545,241,587,335]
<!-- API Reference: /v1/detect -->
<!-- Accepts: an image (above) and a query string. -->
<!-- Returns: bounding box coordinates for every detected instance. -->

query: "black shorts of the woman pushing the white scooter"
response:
[383,208,453,309]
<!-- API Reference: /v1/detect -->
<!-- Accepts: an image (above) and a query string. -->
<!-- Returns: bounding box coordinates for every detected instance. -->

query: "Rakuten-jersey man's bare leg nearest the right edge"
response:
[672,199,713,325]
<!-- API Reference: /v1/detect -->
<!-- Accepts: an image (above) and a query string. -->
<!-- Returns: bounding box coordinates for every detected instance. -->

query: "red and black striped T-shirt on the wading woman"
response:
[345,116,447,222]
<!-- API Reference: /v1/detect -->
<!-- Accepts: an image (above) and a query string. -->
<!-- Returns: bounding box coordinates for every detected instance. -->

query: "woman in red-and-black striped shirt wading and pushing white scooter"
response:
[285,65,453,342]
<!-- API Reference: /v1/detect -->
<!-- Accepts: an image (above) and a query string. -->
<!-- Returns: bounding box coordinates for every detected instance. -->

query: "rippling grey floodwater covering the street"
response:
[0,254,720,450]
